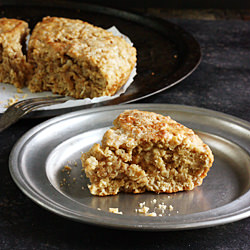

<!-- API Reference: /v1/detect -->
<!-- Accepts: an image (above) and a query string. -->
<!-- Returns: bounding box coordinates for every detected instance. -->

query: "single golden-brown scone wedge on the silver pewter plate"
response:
[81,110,214,196]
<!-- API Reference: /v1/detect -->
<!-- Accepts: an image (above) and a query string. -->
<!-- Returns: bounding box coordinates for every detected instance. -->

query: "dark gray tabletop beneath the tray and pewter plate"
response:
[0,19,250,249]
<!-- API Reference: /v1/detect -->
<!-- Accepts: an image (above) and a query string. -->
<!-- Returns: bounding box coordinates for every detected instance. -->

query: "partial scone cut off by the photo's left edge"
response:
[0,18,32,88]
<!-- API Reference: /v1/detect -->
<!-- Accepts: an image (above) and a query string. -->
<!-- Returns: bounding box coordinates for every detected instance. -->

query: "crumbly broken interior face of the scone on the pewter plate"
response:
[82,128,211,196]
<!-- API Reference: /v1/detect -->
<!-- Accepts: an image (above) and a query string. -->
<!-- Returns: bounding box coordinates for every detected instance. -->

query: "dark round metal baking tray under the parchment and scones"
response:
[0,0,201,117]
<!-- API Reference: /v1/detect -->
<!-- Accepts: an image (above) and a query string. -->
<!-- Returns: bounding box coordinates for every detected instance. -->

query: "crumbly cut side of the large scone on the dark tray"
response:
[29,50,109,98]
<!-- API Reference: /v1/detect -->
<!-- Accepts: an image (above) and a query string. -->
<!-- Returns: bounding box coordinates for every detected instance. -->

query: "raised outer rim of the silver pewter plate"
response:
[9,103,250,231]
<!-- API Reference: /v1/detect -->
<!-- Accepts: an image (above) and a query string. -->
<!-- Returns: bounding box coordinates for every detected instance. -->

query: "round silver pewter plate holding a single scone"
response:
[9,104,250,230]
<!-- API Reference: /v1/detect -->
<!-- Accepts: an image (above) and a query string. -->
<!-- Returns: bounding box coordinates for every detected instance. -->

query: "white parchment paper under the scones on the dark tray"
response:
[0,26,136,113]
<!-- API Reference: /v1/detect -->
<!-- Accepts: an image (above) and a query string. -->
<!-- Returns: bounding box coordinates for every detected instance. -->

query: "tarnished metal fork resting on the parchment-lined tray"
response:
[0,96,70,132]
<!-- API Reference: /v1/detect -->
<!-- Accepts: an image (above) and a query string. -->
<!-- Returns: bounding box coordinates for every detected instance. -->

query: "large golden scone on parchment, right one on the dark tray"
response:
[28,17,136,98]
